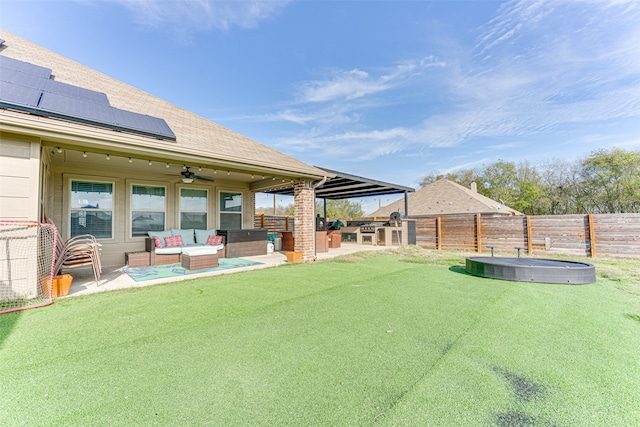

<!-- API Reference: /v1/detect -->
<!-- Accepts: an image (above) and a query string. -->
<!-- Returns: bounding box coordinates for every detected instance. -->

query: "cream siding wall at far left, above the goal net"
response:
[0,133,40,221]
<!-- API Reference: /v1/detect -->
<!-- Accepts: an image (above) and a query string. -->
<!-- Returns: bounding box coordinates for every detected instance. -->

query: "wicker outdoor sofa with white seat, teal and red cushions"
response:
[145,228,225,265]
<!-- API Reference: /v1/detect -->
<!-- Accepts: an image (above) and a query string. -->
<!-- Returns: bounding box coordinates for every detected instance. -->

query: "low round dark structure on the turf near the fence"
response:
[466,257,596,285]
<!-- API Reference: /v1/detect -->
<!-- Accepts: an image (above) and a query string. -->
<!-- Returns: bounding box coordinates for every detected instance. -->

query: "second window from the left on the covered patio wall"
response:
[131,185,166,237]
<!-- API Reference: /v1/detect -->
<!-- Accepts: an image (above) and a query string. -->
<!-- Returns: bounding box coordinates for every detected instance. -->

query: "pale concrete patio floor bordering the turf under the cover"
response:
[67,244,393,297]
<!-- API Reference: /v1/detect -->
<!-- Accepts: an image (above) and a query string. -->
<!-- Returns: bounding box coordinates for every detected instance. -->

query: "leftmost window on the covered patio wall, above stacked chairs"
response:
[71,180,113,239]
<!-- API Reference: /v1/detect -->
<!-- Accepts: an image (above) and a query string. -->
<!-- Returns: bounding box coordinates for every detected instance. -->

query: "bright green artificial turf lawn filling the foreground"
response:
[0,251,640,427]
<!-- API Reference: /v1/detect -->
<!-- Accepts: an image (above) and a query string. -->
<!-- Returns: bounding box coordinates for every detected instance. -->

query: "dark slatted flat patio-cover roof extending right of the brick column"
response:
[269,166,416,199]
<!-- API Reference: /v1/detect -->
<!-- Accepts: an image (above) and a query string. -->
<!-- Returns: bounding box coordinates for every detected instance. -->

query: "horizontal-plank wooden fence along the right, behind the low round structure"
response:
[410,214,640,258]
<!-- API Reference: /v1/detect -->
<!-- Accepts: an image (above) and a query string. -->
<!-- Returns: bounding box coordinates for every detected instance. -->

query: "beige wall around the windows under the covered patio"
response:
[47,150,258,266]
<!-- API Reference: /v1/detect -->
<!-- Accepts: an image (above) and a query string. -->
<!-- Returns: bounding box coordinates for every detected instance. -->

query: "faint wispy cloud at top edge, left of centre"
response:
[117,0,289,33]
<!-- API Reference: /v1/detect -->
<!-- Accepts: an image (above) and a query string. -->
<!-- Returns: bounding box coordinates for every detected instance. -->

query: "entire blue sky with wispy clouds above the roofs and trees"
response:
[0,0,640,213]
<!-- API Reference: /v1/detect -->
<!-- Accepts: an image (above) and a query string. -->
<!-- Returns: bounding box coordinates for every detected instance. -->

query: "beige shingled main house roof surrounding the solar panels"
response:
[0,30,327,179]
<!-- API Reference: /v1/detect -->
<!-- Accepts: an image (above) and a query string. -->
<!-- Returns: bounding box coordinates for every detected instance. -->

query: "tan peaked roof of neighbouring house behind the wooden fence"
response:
[368,179,522,217]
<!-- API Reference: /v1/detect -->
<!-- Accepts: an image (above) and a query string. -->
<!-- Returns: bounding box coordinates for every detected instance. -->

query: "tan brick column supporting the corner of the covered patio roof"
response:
[293,181,316,261]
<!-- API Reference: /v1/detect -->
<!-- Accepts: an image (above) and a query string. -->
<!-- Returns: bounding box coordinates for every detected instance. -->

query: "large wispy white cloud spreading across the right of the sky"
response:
[229,0,640,167]
